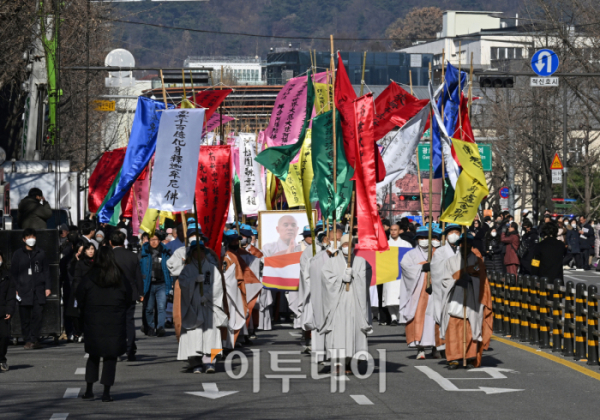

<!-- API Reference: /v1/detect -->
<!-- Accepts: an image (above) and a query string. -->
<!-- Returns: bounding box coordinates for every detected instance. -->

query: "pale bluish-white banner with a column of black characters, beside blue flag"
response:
[148,108,204,211]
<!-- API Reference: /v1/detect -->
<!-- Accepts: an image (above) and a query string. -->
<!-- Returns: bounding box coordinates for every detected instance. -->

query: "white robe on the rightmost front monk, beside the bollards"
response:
[438,252,484,341]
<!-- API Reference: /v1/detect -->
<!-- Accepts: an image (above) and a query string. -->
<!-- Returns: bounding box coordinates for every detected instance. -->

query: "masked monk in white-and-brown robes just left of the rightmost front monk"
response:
[400,225,442,360]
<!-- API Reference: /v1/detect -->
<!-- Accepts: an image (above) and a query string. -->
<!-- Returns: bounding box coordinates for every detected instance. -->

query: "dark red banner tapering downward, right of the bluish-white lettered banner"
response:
[196,146,232,256]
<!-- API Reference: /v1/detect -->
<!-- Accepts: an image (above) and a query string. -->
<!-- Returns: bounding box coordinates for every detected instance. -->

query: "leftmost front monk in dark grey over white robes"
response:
[174,242,228,373]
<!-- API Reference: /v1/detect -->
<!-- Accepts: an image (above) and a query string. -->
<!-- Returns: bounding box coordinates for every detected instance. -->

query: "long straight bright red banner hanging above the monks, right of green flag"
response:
[353,93,390,251]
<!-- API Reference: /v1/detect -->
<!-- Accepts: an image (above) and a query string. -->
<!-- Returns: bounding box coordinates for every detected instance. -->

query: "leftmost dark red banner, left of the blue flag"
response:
[88,147,126,213]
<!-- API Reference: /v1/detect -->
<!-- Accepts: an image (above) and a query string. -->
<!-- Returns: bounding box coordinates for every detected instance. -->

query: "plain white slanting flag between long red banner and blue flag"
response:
[377,105,429,190]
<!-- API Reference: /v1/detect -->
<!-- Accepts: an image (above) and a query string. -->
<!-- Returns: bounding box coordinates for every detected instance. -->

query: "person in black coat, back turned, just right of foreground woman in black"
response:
[110,230,144,362]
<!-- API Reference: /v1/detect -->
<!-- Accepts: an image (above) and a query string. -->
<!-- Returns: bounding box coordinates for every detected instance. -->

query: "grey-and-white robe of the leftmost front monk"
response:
[177,260,228,360]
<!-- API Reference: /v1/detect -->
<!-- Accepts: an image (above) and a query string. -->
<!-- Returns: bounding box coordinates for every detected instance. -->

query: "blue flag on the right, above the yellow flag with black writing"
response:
[431,63,467,178]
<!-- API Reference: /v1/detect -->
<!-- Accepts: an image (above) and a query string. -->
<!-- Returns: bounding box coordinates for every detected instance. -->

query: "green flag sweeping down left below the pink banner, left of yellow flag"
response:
[254,70,315,181]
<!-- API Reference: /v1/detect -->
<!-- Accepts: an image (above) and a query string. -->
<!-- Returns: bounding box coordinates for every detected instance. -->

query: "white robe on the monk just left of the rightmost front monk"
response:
[399,246,435,347]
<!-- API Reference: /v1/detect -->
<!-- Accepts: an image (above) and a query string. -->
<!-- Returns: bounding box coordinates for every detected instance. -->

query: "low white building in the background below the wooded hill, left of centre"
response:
[183,56,266,86]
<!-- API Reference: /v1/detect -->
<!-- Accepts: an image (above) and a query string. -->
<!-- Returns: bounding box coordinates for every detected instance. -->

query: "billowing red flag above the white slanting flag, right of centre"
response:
[373,82,429,141]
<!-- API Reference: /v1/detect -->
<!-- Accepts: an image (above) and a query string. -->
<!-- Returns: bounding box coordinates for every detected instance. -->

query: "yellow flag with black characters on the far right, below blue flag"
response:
[440,139,490,226]
